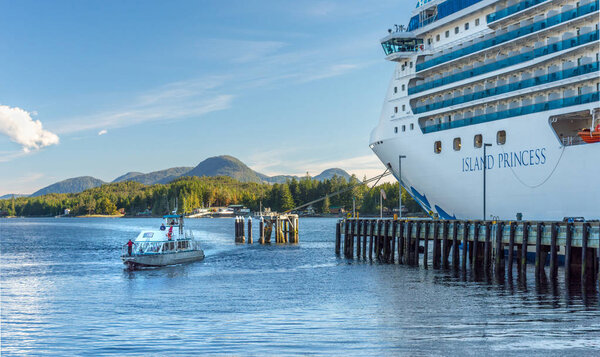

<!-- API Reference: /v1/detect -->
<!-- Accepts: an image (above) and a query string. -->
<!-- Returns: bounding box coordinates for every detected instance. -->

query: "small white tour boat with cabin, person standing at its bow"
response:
[121,214,204,269]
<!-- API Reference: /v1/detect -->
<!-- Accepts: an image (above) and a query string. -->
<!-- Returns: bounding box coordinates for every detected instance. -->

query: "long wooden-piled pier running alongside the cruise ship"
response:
[335,219,600,282]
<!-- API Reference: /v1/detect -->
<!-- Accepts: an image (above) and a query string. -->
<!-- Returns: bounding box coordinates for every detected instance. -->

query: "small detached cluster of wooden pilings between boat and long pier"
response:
[235,214,299,244]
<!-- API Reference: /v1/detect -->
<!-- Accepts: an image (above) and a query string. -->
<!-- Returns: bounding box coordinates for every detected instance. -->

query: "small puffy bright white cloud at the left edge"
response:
[0,105,59,152]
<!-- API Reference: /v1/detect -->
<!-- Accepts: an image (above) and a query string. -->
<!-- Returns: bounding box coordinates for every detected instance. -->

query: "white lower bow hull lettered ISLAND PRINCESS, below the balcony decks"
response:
[372,106,600,220]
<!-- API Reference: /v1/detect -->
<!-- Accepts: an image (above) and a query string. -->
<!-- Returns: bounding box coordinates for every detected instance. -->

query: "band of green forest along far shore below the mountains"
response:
[0,175,420,216]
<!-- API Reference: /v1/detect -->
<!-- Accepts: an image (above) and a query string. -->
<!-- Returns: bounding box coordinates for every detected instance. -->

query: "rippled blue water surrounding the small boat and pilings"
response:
[0,218,600,356]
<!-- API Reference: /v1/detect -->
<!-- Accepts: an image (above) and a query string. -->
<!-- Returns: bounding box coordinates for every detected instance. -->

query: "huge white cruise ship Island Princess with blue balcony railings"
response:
[370,0,600,220]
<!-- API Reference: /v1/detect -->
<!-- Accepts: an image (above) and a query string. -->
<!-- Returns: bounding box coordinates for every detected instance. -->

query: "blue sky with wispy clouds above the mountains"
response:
[0,0,415,195]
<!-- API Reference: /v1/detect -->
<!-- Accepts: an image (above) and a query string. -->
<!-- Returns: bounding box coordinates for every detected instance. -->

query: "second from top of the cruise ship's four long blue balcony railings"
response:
[408,30,599,95]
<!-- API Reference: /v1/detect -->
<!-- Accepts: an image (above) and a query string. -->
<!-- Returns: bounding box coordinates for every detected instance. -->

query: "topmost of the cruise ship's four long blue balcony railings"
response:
[416,1,599,72]
